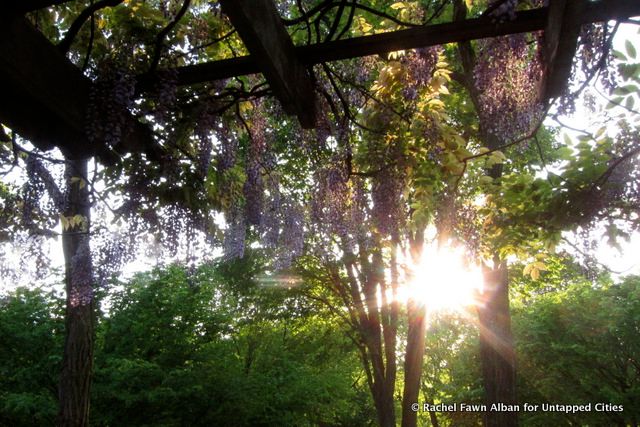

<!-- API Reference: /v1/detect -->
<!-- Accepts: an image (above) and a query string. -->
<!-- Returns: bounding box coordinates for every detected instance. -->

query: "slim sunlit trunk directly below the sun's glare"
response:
[402,299,427,427]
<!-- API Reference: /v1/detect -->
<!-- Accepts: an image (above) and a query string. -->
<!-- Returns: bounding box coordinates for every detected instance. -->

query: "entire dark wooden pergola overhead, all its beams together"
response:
[0,0,640,158]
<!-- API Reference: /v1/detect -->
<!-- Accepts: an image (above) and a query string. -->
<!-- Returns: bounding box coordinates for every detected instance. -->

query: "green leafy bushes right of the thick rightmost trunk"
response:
[514,276,640,426]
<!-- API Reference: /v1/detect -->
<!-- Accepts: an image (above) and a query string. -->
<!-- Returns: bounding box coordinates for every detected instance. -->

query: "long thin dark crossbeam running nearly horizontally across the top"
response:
[146,0,640,87]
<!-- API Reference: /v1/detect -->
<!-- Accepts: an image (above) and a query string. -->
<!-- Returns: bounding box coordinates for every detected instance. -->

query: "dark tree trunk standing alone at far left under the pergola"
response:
[58,159,94,427]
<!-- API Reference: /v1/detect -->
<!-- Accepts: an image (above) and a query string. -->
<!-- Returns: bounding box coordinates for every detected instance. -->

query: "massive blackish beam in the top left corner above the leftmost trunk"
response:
[0,16,157,159]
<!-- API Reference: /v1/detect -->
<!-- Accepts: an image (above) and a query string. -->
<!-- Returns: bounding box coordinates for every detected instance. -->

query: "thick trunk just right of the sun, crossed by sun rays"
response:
[478,262,518,427]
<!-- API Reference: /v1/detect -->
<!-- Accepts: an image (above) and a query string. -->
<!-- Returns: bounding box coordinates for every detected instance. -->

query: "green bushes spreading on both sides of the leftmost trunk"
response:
[0,265,372,426]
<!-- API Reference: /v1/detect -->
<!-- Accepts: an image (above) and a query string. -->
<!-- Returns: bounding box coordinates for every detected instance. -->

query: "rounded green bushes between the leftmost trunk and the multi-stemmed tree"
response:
[93,260,366,426]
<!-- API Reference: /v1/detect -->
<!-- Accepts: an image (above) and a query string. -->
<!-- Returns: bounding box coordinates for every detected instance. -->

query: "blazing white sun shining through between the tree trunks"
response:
[400,244,482,311]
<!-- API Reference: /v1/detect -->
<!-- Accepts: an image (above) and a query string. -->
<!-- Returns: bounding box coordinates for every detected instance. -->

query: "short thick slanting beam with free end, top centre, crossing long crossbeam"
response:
[220,0,315,128]
